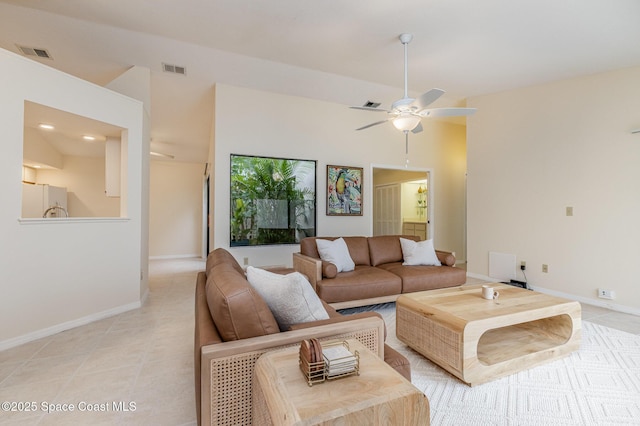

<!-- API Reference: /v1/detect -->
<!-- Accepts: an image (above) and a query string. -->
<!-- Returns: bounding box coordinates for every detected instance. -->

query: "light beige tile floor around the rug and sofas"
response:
[0,259,640,425]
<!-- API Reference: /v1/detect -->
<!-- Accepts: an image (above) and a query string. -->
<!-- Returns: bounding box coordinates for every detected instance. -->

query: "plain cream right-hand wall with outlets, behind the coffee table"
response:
[467,67,640,314]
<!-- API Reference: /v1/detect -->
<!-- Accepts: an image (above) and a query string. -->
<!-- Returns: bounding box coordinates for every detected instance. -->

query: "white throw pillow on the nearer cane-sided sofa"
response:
[242,266,329,331]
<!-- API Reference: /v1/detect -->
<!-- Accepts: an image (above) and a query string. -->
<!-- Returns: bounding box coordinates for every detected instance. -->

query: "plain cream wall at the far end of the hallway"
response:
[149,161,204,258]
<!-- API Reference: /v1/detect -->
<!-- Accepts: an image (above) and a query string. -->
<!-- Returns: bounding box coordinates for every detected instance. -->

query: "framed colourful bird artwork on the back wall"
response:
[327,165,362,216]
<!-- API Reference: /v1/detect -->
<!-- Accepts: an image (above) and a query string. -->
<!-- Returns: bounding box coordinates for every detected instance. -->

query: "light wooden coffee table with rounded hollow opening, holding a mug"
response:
[396,284,581,386]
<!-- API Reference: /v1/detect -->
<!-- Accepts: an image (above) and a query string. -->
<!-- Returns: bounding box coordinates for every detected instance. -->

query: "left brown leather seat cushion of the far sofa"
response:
[316,265,402,303]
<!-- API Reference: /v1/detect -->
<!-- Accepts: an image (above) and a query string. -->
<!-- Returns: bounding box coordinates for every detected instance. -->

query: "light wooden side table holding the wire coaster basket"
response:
[253,340,429,426]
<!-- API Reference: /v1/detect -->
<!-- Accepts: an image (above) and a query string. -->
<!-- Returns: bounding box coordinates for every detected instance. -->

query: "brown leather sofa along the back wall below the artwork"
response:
[293,235,467,309]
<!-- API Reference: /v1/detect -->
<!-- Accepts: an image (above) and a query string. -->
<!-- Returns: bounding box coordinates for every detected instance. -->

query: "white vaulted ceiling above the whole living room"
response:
[0,0,640,162]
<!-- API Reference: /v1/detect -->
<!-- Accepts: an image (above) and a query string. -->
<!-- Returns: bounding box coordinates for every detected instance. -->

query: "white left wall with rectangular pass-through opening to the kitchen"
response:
[0,50,148,350]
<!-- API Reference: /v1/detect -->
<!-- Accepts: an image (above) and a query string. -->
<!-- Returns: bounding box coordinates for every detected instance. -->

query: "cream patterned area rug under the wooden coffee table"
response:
[341,303,640,426]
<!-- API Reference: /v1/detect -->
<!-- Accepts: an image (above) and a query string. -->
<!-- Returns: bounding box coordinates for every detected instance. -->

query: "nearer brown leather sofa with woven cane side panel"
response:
[194,248,411,425]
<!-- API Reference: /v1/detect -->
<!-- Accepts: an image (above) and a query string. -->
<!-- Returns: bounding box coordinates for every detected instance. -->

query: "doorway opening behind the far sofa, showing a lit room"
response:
[371,165,433,240]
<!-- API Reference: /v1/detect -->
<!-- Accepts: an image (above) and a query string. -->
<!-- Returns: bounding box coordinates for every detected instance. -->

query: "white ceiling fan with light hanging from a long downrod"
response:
[350,34,476,136]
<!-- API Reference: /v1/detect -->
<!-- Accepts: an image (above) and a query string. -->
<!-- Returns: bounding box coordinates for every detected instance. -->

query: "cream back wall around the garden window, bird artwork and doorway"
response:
[212,85,466,265]
